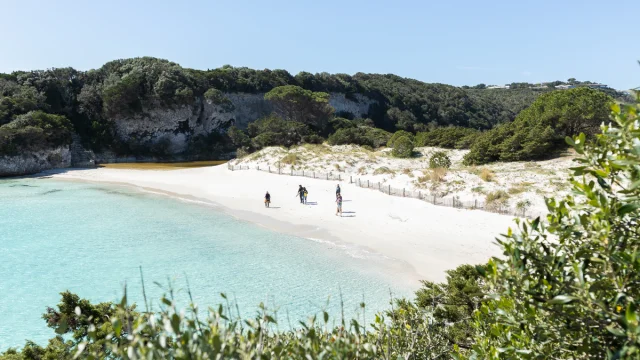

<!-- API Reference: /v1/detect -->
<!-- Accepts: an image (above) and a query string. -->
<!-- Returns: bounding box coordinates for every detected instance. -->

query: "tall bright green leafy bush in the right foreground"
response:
[464,100,640,359]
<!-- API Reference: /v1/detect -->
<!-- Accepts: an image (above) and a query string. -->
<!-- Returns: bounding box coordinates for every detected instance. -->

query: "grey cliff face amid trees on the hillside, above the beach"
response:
[106,93,374,154]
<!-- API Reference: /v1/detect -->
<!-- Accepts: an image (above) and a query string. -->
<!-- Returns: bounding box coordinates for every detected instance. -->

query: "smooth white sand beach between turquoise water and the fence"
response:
[53,165,513,283]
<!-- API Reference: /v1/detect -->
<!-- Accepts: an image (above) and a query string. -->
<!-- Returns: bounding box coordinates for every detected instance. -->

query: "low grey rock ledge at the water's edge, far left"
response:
[0,146,71,177]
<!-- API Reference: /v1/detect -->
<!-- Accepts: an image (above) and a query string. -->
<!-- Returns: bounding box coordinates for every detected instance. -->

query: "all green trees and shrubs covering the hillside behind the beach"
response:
[0,57,626,163]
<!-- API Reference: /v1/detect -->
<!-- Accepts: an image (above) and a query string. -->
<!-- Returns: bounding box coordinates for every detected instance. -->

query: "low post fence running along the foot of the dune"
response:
[227,164,545,219]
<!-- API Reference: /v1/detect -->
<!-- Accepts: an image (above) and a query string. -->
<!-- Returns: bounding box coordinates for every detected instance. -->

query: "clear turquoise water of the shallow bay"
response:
[0,178,412,350]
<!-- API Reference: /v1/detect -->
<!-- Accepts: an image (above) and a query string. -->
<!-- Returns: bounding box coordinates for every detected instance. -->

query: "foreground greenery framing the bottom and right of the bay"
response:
[0,96,640,360]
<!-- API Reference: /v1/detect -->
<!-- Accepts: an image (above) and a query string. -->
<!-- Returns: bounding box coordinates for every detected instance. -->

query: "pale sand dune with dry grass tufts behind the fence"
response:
[232,144,576,217]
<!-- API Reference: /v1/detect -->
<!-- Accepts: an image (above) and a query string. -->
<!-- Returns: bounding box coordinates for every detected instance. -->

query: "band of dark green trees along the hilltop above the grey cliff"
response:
[0,57,544,157]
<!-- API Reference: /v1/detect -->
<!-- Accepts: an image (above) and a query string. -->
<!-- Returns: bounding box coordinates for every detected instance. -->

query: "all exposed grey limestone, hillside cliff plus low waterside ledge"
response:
[0,93,375,176]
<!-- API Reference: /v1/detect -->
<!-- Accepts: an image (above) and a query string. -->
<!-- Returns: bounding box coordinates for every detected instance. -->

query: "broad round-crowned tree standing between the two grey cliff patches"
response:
[264,85,334,131]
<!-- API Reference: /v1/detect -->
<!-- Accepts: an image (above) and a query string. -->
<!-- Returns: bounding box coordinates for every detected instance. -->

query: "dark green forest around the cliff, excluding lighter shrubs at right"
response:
[0,57,632,162]
